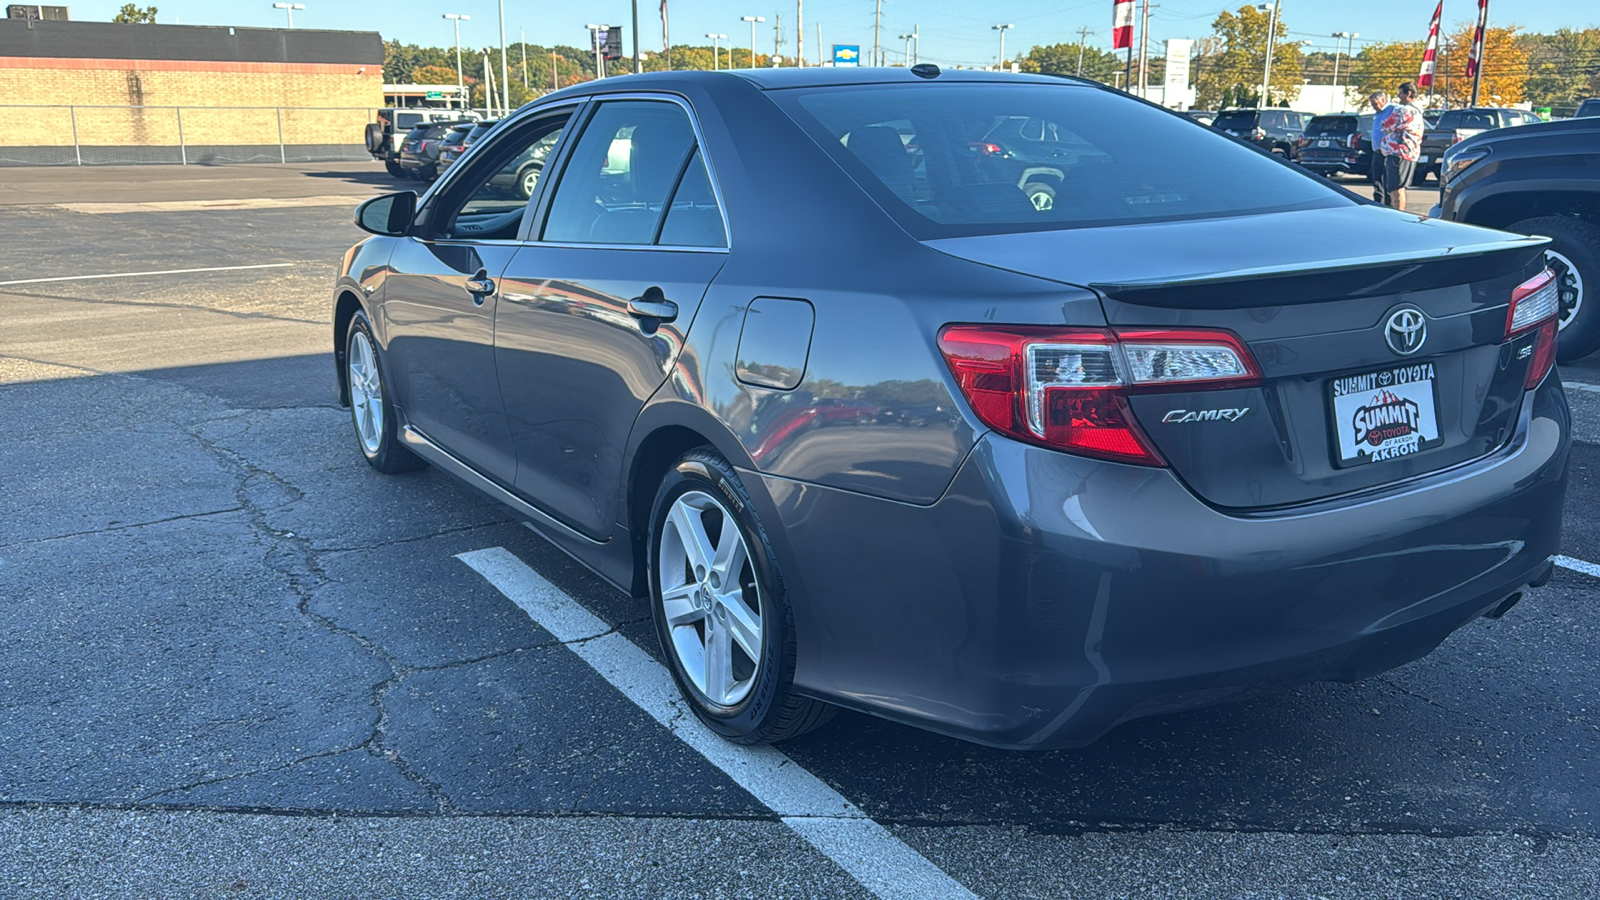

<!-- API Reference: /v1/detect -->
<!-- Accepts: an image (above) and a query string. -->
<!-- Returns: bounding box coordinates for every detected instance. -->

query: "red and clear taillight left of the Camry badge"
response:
[939,325,1261,466]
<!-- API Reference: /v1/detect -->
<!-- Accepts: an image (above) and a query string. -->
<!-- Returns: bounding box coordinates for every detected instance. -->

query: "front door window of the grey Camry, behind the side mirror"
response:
[437,117,566,240]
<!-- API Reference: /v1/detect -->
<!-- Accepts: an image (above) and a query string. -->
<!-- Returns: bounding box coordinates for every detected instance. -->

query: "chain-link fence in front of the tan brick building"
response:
[0,104,378,167]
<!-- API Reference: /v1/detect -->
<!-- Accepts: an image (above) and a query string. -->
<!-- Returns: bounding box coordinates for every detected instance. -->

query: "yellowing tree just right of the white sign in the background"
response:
[1195,6,1304,107]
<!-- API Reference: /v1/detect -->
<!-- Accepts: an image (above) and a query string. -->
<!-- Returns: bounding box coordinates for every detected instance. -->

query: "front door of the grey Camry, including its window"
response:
[382,109,571,484]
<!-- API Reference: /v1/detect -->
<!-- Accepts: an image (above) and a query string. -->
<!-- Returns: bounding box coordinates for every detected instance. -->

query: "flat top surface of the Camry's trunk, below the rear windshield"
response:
[926,205,1546,291]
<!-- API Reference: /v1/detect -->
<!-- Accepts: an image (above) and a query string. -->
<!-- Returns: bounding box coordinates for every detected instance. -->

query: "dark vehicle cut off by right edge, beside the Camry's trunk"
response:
[1434,114,1600,362]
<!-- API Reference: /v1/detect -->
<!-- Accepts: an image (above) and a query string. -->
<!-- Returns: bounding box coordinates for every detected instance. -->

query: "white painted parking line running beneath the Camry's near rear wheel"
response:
[456,548,974,900]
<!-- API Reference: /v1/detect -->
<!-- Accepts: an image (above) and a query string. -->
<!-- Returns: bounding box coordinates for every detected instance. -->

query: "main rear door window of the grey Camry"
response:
[542,101,694,243]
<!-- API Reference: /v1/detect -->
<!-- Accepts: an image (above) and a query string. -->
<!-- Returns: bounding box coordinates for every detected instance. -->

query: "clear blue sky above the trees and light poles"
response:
[68,0,1600,66]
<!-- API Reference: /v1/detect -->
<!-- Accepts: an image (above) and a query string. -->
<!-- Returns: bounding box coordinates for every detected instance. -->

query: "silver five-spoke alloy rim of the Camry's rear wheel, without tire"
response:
[656,490,765,706]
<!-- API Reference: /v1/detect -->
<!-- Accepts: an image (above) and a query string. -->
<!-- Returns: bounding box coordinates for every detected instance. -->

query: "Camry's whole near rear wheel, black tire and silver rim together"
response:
[650,447,835,743]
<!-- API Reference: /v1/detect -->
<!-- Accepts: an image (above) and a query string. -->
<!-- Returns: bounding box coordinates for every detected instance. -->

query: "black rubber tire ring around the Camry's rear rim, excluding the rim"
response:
[648,450,794,738]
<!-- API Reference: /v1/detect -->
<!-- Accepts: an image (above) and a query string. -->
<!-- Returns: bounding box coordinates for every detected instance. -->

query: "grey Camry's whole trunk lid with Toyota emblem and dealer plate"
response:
[928,207,1542,509]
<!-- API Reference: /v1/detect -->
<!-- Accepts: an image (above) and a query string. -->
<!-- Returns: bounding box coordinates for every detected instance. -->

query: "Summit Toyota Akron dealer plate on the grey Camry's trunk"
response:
[1328,362,1442,466]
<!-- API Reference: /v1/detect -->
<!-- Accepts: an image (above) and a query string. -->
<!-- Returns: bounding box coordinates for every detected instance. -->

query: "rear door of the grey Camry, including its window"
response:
[494,96,728,540]
